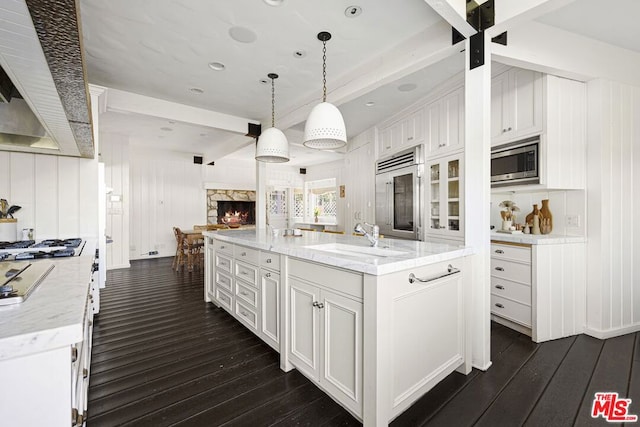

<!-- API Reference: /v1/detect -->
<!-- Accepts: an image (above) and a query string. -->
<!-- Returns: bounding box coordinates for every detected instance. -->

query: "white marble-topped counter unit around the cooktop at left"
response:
[0,242,98,427]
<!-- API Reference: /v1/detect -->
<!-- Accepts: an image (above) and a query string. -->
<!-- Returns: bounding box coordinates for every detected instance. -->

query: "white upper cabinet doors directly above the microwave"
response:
[491,68,543,145]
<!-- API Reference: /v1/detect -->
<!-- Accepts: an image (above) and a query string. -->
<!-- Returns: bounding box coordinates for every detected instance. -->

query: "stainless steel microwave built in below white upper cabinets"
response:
[491,137,540,187]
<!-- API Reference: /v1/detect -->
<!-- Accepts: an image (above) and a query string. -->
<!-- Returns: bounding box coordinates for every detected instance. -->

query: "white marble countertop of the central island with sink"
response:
[203,230,473,276]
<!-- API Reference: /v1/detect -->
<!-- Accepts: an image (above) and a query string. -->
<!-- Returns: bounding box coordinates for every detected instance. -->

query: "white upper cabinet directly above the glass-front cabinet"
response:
[425,88,464,157]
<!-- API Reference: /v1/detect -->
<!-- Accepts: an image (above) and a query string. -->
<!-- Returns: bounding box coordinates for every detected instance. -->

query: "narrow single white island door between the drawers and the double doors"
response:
[260,270,280,351]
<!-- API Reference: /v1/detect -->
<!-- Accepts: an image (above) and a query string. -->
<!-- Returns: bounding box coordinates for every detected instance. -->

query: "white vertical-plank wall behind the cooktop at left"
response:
[0,151,98,240]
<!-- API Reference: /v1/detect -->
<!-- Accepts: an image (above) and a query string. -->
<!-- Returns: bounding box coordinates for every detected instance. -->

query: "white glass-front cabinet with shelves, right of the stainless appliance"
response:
[426,154,464,239]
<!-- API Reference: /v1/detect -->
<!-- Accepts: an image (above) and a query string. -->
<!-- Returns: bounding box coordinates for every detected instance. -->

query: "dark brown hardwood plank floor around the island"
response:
[87,258,640,427]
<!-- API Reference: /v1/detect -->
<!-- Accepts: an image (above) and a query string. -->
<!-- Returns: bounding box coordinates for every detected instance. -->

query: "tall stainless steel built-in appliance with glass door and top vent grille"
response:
[376,146,423,240]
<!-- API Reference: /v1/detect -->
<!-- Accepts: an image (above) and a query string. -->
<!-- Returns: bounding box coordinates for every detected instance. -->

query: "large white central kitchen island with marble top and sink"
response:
[204,230,471,426]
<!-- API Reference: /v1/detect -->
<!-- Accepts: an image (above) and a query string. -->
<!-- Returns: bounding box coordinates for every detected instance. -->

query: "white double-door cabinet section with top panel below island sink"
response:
[288,259,363,417]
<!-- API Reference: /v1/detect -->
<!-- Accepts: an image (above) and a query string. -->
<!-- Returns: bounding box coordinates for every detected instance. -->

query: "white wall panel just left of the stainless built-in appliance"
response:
[344,132,375,233]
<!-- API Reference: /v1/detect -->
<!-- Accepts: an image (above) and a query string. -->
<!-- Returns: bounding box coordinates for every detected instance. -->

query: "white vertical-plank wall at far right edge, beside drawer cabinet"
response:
[587,80,640,338]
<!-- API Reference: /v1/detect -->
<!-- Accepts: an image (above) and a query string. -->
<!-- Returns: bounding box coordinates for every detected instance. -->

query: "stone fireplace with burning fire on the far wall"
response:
[207,190,256,225]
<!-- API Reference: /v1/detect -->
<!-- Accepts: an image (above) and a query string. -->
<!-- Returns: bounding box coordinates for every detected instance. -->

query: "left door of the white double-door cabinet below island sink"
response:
[289,278,320,381]
